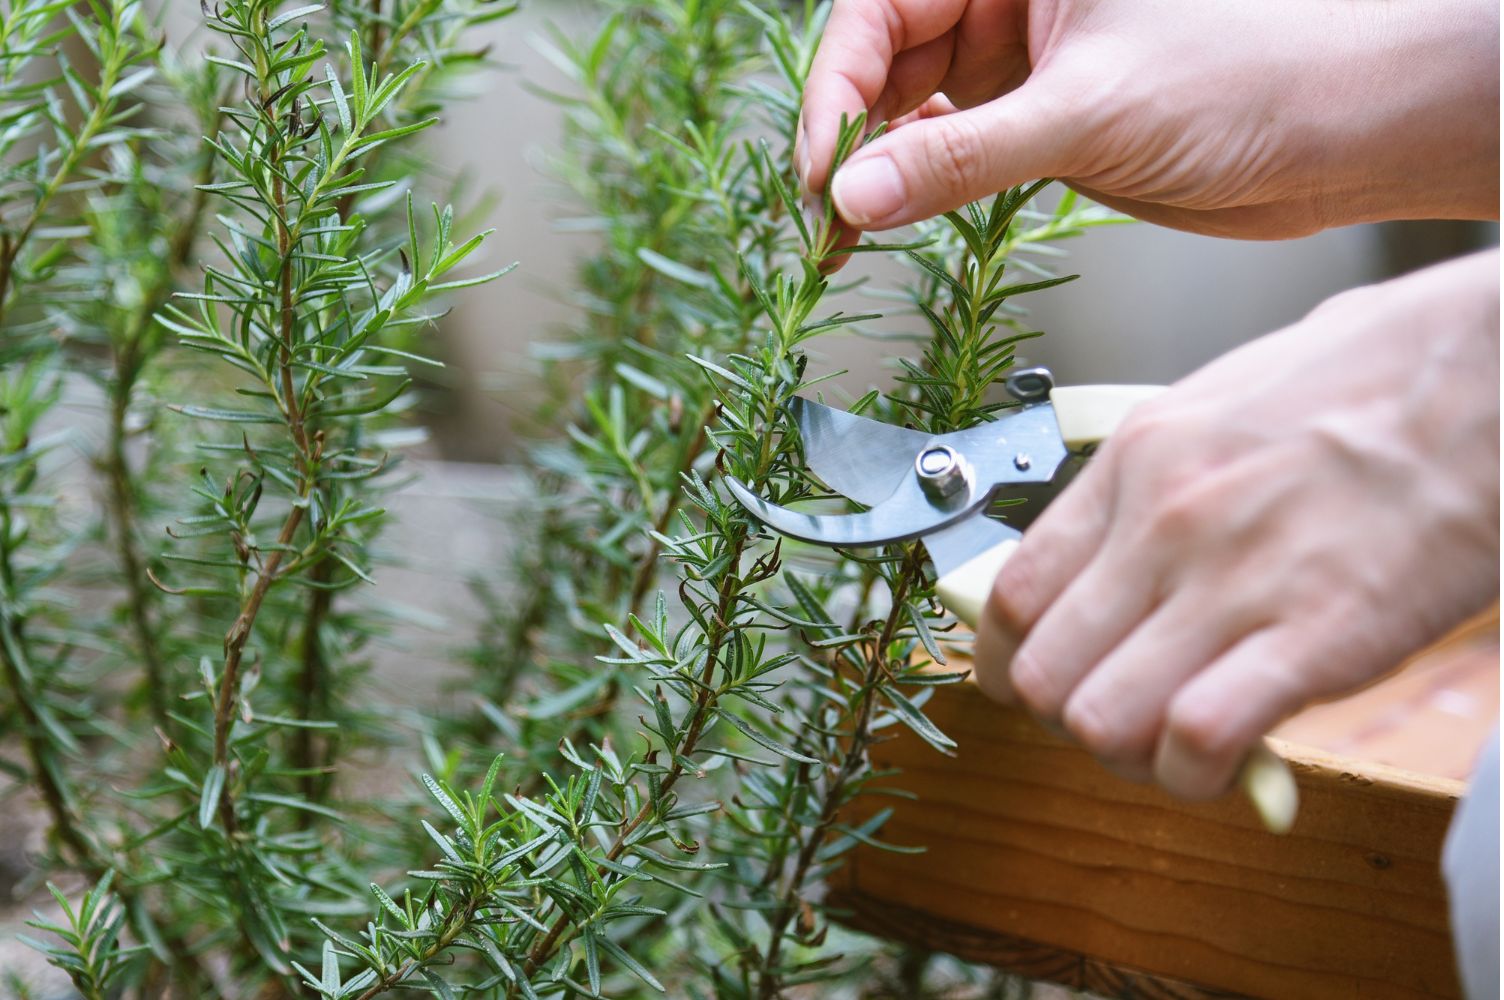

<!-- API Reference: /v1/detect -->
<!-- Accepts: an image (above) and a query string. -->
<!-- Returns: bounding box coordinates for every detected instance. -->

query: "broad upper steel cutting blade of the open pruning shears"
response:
[790,395,929,507]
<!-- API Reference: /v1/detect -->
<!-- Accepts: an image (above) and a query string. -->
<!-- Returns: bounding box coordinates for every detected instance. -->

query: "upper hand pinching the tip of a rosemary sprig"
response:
[796,0,1499,239]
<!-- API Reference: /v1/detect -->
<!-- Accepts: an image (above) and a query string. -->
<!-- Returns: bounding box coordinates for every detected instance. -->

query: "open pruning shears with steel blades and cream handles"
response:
[726,368,1298,833]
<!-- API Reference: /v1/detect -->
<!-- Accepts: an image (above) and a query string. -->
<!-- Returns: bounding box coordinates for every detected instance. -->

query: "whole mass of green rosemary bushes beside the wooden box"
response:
[0,0,1110,1000]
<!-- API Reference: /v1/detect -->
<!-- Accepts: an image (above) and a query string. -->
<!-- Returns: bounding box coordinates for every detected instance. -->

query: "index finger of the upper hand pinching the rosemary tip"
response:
[796,0,967,191]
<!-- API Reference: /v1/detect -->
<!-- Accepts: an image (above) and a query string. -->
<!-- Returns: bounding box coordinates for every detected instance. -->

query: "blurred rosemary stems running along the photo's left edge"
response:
[0,0,149,875]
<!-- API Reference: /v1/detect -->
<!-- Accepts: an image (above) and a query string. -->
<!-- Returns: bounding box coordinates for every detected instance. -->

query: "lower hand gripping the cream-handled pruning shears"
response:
[976,251,1499,798]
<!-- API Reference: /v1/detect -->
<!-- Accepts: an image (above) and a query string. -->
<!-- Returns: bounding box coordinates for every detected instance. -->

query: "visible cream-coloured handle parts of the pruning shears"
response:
[935,385,1299,833]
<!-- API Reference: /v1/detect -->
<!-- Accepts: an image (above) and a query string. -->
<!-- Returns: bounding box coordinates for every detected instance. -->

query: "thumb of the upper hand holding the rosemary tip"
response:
[830,81,1081,229]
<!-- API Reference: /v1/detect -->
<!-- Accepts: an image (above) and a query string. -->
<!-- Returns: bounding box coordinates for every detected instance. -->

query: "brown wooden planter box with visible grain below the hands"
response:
[830,611,1498,1000]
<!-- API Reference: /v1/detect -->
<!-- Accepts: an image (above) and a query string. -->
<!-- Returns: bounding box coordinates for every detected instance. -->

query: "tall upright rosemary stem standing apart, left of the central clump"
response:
[144,2,514,974]
